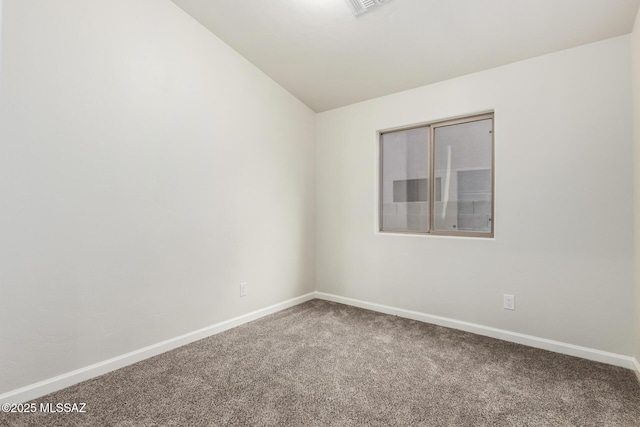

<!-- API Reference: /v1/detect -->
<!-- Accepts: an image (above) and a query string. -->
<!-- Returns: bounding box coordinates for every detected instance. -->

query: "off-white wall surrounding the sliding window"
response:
[316,36,633,356]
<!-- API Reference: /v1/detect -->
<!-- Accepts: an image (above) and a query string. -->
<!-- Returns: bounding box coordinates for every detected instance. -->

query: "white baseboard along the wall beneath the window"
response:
[316,292,640,372]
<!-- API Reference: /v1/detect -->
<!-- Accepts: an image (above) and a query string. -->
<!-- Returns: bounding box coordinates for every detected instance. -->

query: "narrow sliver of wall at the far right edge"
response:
[631,6,640,368]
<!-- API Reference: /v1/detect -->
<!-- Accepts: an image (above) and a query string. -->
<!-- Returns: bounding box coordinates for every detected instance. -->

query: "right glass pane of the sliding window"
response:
[434,119,493,233]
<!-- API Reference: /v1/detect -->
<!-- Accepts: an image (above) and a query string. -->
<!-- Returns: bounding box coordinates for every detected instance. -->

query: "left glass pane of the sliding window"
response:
[380,127,429,232]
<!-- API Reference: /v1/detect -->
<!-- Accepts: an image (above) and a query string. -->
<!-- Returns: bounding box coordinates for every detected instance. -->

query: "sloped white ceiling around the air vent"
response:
[172,0,640,112]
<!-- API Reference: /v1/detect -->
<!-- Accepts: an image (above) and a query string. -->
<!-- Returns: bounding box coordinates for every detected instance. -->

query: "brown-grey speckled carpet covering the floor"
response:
[0,300,640,427]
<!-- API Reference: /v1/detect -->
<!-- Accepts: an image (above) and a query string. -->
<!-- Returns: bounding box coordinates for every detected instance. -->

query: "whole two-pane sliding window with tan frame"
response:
[379,114,495,237]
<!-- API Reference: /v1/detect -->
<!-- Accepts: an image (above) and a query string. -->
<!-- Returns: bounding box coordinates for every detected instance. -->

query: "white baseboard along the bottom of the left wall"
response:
[0,292,315,404]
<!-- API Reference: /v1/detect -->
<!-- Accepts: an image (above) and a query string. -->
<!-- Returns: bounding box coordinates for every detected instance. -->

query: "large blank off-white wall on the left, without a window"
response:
[0,0,315,393]
